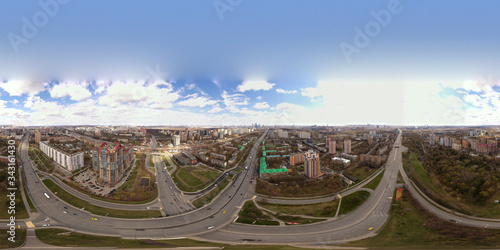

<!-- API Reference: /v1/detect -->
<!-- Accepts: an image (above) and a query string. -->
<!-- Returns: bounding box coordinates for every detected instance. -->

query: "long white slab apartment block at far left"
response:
[39,141,84,171]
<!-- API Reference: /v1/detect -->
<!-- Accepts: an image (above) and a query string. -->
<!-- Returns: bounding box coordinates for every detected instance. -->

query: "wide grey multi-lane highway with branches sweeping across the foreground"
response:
[8,129,500,244]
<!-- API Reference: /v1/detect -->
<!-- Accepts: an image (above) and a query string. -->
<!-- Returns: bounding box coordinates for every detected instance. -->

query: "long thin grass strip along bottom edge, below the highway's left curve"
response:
[35,229,316,250]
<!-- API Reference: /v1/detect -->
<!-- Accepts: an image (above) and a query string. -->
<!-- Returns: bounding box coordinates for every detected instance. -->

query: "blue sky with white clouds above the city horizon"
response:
[0,0,500,125]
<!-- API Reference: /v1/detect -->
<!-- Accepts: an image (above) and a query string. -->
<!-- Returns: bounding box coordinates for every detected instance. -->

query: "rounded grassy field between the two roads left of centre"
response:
[172,165,221,192]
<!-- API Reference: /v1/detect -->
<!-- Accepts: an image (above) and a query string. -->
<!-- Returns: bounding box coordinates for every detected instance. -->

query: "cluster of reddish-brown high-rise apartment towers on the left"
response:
[92,143,134,185]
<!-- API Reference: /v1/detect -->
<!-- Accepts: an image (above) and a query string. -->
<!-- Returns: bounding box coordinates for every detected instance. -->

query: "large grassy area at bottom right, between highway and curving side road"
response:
[344,191,500,249]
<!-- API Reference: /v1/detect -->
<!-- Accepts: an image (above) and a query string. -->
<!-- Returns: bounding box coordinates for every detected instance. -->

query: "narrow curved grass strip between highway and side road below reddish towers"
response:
[43,180,161,219]
